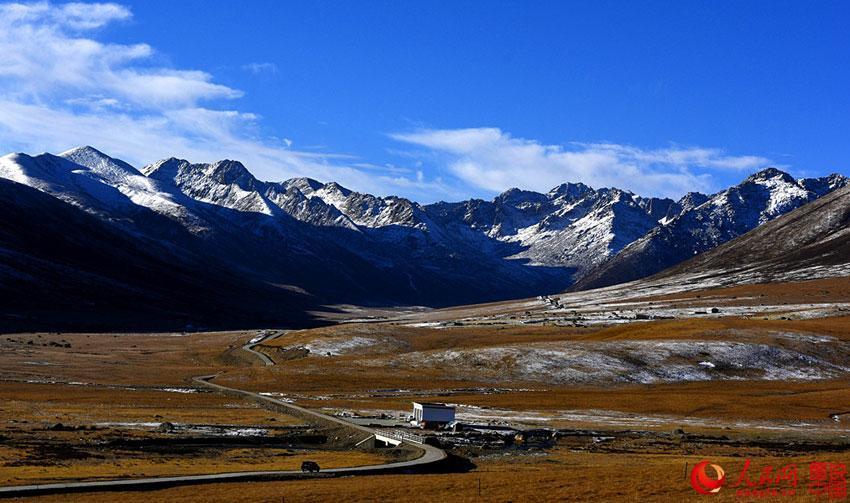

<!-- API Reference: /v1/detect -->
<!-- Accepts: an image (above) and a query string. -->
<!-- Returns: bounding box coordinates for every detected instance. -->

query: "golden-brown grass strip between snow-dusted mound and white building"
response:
[282,378,850,428]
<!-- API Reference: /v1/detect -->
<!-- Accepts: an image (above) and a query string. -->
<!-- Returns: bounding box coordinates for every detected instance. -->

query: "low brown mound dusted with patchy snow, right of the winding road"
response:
[397,341,847,384]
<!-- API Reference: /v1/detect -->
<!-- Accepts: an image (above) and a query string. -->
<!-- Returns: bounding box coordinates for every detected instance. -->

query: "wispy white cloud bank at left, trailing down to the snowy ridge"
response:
[0,2,439,197]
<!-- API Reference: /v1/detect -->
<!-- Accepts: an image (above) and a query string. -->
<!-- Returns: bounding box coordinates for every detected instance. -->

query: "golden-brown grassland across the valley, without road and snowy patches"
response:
[0,280,850,501]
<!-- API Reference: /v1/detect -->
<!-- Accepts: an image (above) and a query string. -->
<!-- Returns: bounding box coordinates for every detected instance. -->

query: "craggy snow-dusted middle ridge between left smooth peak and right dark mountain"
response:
[136,150,679,282]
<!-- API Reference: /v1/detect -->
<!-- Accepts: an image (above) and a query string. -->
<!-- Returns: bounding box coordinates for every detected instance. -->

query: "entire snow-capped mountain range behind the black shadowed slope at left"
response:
[0,147,847,328]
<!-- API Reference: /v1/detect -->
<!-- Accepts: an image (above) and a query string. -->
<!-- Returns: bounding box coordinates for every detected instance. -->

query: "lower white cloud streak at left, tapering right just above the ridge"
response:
[0,99,410,194]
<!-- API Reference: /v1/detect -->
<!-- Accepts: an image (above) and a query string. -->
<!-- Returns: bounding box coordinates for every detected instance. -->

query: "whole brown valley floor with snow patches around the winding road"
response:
[0,279,850,501]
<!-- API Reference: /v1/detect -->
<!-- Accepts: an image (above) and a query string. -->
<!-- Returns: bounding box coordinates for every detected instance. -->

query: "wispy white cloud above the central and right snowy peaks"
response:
[390,128,769,197]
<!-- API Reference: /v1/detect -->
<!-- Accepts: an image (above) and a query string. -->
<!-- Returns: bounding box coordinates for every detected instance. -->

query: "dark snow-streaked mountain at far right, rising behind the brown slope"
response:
[575,168,848,289]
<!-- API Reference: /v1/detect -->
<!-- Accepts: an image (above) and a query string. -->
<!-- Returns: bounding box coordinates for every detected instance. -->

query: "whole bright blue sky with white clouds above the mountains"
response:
[0,1,850,202]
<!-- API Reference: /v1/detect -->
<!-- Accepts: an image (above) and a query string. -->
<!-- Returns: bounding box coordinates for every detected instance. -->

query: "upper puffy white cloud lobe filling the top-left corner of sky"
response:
[0,2,242,109]
